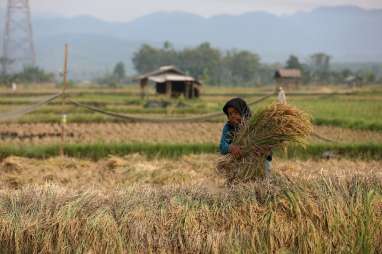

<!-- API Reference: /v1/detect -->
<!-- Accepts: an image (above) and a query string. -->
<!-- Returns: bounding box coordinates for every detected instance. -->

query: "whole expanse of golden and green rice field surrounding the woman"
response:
[0,86,382,253]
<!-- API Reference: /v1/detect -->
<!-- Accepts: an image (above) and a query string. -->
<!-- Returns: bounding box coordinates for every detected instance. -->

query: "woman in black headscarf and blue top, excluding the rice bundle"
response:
[219,98,272,176]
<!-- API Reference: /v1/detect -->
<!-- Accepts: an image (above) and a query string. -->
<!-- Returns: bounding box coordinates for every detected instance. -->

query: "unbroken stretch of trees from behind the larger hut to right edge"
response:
[133,42,382,86]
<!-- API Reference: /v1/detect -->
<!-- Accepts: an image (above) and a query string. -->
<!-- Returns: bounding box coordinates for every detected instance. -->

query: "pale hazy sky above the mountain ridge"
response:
[1,0,382,21]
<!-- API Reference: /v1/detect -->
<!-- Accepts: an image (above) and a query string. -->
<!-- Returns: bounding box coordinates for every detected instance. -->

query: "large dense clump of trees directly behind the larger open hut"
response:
[133,42,272,85]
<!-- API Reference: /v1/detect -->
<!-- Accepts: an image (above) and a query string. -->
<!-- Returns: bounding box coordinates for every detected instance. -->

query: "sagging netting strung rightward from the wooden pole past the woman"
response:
[69,94,274,123]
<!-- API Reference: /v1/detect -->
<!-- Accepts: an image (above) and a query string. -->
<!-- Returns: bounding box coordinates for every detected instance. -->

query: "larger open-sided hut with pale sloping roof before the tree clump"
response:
[138,66,202,99]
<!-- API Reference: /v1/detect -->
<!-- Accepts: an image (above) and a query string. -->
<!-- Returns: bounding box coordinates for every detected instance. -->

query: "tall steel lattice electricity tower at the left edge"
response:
[0,0,36,74]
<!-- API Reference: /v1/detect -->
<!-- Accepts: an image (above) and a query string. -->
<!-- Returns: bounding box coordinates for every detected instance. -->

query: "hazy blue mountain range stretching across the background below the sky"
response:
[0,6,382,79]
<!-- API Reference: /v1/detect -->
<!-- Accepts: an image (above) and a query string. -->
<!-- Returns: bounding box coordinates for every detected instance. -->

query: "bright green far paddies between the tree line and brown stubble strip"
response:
[0,88,382,131]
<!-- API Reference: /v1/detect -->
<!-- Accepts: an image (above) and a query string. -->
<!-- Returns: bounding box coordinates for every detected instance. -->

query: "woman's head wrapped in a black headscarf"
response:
[223,98,251,125]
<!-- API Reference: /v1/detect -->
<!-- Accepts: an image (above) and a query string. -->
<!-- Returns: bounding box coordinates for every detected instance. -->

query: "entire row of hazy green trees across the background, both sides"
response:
[0,42,382,86]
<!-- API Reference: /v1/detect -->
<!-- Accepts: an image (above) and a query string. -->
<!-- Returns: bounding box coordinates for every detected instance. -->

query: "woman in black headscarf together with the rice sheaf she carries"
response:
[217,98,313,185]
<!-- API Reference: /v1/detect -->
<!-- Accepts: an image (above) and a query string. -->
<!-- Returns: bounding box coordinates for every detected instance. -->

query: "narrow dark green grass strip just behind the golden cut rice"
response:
[0,143,382,160]
